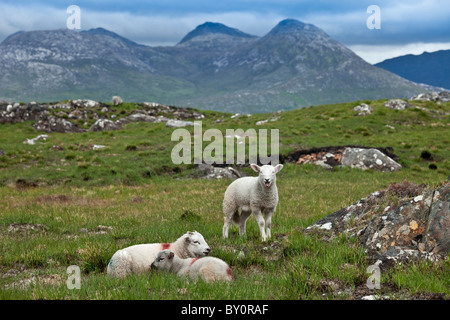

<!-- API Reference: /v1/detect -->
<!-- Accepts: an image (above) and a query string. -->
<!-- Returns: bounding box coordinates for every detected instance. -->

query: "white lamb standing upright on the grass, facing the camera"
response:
[223,164,283,241]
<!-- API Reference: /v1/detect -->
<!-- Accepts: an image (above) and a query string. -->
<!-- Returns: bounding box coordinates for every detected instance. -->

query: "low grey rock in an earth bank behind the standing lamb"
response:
[285,145,401,172]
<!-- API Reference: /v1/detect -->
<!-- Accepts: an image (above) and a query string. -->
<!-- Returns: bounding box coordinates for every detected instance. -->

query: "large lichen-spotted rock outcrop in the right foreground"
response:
[305,181,450,267]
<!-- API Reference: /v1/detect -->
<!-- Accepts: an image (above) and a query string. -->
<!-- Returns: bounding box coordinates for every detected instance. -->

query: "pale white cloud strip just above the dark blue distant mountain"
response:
[348,42,450,64]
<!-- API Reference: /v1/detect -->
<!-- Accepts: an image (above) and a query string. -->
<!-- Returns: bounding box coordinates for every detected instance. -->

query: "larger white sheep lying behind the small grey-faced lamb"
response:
[106,231,211,278]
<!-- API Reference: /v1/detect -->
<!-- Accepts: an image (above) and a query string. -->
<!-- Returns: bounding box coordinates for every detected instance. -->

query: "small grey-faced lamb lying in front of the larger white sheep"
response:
[152,250,233,282]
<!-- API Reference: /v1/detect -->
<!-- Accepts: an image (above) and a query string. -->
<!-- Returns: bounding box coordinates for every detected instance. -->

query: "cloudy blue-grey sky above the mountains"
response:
[0,0,450,63]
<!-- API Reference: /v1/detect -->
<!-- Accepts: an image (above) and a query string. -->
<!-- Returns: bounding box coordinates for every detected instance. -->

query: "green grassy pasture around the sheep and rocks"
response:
[0,100,450,299]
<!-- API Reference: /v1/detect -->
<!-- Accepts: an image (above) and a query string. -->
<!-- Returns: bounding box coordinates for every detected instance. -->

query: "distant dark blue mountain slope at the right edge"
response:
[375,50,450,90]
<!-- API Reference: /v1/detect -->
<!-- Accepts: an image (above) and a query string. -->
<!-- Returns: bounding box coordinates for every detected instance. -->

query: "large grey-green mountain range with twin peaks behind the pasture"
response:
[0,19,424,113]
